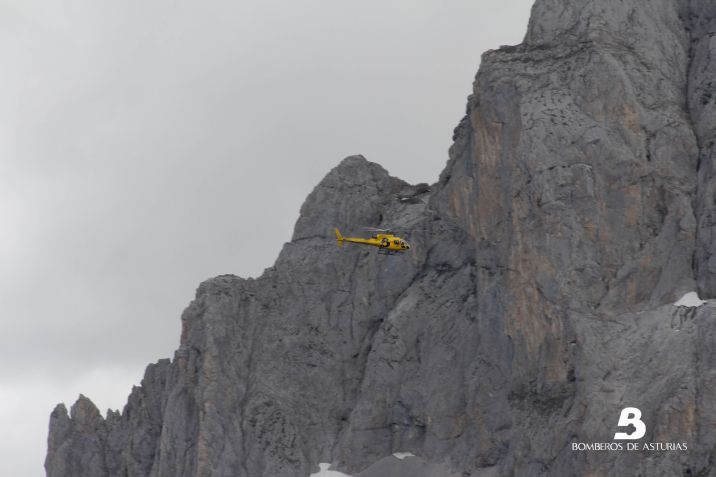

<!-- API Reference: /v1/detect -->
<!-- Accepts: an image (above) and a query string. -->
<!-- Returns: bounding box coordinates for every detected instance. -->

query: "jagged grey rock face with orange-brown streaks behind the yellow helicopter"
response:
[45,0,716,477]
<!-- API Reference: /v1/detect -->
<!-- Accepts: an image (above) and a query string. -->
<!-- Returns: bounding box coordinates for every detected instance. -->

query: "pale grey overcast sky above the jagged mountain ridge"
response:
[0,0,532,477]
